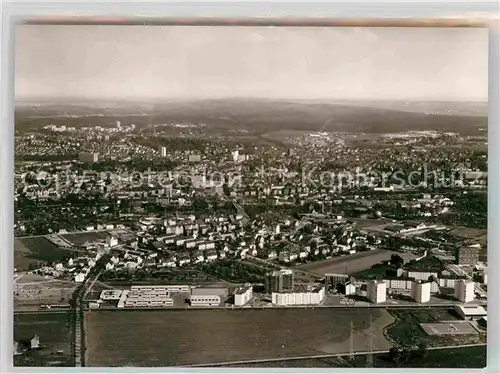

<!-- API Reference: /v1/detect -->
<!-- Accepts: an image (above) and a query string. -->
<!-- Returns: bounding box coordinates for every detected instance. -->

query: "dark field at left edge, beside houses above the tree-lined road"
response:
[14,236,77,271]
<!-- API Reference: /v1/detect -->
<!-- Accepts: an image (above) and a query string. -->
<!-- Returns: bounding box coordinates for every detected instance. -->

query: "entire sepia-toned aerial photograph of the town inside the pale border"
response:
[9,23,489,371]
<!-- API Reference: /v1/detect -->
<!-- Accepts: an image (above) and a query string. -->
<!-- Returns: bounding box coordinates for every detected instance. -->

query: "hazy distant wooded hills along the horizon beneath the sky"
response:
[15,99,487,134]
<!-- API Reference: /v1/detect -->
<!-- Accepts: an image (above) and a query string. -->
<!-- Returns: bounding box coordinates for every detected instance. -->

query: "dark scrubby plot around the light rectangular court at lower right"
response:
[386,308,486,347]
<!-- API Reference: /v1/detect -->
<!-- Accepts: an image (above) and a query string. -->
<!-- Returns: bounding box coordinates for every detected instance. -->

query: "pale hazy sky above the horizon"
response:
[14,25,488,101]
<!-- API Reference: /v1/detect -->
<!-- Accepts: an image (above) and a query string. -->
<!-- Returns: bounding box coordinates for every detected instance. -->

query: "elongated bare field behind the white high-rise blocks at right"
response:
[296,250,394,276]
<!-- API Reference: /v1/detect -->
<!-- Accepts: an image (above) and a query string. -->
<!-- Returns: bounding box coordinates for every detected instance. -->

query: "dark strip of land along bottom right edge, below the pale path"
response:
[228,345,487,369]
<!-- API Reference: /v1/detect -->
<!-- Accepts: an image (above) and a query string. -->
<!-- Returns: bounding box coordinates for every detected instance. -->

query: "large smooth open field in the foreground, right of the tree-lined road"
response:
[85,308,393,367]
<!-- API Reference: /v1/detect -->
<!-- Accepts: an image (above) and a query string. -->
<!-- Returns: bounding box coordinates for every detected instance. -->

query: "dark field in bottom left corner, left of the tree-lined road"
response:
[14,311,74,367]
